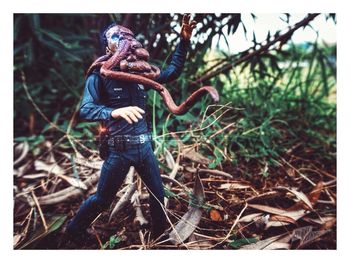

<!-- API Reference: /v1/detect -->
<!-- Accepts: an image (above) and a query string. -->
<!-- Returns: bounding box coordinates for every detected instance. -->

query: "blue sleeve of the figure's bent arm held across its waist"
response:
[79,74,114,121]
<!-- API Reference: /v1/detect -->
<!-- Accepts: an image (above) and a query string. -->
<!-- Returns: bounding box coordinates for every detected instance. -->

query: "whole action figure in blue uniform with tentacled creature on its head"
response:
[66,15,218,242]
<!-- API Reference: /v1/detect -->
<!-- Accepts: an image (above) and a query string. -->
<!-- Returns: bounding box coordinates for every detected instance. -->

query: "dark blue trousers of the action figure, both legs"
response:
[67,141,166,235]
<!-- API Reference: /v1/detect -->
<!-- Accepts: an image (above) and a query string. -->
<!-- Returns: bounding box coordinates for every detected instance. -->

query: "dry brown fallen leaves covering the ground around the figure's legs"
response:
[13,139,336,250]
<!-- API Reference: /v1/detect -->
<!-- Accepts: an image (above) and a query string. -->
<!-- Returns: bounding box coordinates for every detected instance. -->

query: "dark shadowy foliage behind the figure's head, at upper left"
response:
[14,14,240,147]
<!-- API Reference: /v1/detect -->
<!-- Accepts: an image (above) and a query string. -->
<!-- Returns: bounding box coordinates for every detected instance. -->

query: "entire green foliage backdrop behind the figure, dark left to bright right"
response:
[14,14,336,179]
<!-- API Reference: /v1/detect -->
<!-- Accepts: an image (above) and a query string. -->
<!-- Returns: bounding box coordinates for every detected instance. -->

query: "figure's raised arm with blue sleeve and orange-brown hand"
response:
[150,14,197,83]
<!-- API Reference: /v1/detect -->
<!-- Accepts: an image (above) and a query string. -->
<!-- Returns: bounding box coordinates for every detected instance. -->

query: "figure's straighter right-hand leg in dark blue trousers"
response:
[135,143,167,237]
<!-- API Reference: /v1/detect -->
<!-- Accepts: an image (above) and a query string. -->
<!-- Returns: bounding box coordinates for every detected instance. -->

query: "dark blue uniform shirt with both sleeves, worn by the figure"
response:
[80,40,189,135]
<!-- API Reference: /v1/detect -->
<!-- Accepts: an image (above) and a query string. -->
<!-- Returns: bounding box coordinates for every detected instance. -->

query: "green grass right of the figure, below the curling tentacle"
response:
[147,41,336,176]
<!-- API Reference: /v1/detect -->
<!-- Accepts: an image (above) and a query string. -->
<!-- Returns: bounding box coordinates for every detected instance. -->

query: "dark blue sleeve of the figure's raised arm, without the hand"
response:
[155,39,190,83]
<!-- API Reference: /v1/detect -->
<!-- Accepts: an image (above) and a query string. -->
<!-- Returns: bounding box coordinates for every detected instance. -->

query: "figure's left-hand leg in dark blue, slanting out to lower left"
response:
[67,152,130,234]
